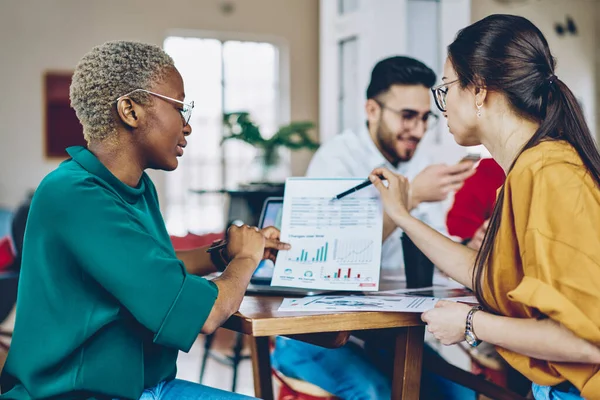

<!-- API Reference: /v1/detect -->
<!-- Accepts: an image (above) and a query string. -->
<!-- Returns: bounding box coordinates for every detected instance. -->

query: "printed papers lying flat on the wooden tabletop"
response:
[278,296,440,313]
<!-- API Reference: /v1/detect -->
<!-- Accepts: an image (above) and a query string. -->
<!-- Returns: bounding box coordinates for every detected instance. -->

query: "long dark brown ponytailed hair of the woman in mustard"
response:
[448,14,600,309]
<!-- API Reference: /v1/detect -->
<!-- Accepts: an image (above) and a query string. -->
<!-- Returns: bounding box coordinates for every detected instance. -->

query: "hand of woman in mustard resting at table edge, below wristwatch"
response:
[421,300,471,346]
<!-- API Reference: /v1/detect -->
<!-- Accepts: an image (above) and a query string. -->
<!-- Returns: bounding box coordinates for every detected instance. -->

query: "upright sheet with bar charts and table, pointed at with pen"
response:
[271,178,383,291]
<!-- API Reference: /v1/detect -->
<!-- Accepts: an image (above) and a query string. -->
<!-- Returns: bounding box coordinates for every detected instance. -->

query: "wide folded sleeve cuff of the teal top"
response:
[154,275,219,352]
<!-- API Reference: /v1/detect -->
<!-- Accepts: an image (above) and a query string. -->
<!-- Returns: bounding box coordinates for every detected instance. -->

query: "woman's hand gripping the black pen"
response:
[369,168,410,225]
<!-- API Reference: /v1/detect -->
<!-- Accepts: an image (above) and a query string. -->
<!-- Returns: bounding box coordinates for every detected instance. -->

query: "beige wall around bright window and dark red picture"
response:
[0,0,319,207]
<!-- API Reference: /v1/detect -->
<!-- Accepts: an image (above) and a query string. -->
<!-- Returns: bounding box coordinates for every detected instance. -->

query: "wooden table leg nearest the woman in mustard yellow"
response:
[392,326,425,400]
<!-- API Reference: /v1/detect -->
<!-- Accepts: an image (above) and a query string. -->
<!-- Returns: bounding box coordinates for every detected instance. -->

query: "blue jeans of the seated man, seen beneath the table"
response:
[271,337,476,400]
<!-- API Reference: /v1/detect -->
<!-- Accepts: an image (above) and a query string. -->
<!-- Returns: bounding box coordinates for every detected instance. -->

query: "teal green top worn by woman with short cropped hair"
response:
[0,147,217,399]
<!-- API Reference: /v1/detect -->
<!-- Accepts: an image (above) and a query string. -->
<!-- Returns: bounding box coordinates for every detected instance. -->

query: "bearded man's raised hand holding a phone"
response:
[410,161,475,209]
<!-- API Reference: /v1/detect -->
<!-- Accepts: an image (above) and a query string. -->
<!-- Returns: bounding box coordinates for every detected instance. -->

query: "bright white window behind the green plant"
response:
[164,36,282,235]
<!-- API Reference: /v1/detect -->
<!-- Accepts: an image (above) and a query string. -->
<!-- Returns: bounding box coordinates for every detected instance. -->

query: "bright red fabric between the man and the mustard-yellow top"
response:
[446,158,506,240]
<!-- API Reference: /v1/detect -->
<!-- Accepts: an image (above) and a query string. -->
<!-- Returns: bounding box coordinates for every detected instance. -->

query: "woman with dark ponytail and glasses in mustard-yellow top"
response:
[370,15,600,399]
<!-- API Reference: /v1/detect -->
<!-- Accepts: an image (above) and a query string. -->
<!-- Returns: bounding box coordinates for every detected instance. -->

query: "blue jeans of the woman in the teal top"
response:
[140,379,252,400]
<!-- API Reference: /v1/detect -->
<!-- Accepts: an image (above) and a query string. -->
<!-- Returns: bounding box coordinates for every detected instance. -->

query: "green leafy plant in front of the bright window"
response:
[221,112,319,181]
